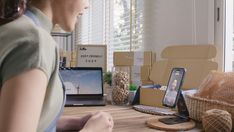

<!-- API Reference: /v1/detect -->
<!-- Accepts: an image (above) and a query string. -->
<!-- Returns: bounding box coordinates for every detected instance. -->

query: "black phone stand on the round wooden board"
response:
[159,91,189,125]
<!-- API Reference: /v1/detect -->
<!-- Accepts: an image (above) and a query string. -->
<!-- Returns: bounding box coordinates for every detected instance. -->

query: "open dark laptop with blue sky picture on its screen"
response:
[59,67,105,106]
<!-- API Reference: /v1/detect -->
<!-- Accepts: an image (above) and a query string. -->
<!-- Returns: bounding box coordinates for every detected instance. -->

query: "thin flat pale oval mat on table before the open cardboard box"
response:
[133,105,175,115]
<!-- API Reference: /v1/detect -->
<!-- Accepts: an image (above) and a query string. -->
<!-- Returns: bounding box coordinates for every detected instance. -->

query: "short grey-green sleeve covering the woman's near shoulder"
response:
[0,16,57,82]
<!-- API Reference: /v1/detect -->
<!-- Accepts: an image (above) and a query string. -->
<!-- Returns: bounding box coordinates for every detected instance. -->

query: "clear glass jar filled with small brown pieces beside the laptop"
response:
[112,67,130,105]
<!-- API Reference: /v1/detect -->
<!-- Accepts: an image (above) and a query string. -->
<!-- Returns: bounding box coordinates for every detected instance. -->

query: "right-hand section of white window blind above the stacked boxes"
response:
[111,0,143,51]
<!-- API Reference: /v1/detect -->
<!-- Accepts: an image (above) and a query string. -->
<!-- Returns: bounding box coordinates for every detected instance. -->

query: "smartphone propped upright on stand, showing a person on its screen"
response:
[163,68,186,108]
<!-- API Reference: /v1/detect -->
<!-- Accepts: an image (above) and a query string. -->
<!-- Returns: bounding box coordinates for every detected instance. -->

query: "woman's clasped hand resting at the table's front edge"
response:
[80,112,114,132]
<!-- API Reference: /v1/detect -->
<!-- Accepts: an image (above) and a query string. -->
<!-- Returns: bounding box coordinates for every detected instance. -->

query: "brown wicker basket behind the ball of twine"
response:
[185,94,234,128]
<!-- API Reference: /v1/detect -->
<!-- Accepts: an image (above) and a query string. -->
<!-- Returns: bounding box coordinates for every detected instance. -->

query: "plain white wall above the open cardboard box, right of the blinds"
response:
[144,0,214,59]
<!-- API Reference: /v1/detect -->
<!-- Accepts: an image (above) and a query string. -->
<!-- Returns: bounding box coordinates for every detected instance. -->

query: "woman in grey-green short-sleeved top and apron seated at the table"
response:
[0,0,113,132]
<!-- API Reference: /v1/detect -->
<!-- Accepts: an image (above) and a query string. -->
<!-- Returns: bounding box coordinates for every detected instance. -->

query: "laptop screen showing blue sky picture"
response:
[60,68,103,95]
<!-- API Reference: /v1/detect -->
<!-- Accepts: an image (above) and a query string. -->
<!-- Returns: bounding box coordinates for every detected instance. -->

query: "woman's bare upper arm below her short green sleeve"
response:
[0,69,47,132]
